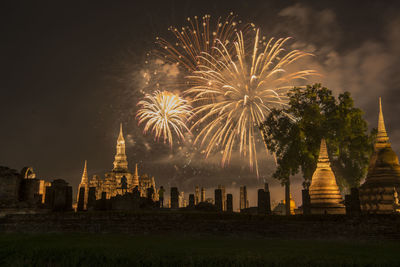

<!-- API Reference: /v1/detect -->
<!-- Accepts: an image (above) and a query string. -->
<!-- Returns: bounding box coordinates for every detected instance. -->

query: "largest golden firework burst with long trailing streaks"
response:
[185,30,316,176]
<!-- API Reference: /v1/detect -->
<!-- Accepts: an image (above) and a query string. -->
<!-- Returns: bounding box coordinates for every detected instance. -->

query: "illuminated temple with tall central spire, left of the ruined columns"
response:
[77,124,157,209]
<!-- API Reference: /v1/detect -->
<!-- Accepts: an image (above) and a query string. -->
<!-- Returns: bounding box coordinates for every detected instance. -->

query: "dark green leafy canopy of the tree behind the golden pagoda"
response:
[260,84,376,189]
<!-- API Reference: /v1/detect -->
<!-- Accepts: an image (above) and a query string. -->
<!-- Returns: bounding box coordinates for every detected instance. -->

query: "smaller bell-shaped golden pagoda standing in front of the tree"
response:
[309,139,346,214]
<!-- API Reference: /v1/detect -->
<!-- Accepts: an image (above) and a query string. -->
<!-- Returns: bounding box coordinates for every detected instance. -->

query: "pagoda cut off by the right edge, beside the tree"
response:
[360,98,400,214]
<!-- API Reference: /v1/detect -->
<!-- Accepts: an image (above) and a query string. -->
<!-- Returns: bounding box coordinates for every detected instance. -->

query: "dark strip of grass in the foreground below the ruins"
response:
[0,234,400,266]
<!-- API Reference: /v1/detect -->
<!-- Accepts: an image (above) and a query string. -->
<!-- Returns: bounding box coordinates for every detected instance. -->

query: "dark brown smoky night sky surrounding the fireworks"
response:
[0,0,400,207]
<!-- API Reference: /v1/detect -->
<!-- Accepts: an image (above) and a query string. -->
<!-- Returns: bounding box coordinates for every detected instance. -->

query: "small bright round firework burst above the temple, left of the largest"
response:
[136,91,192,146]
